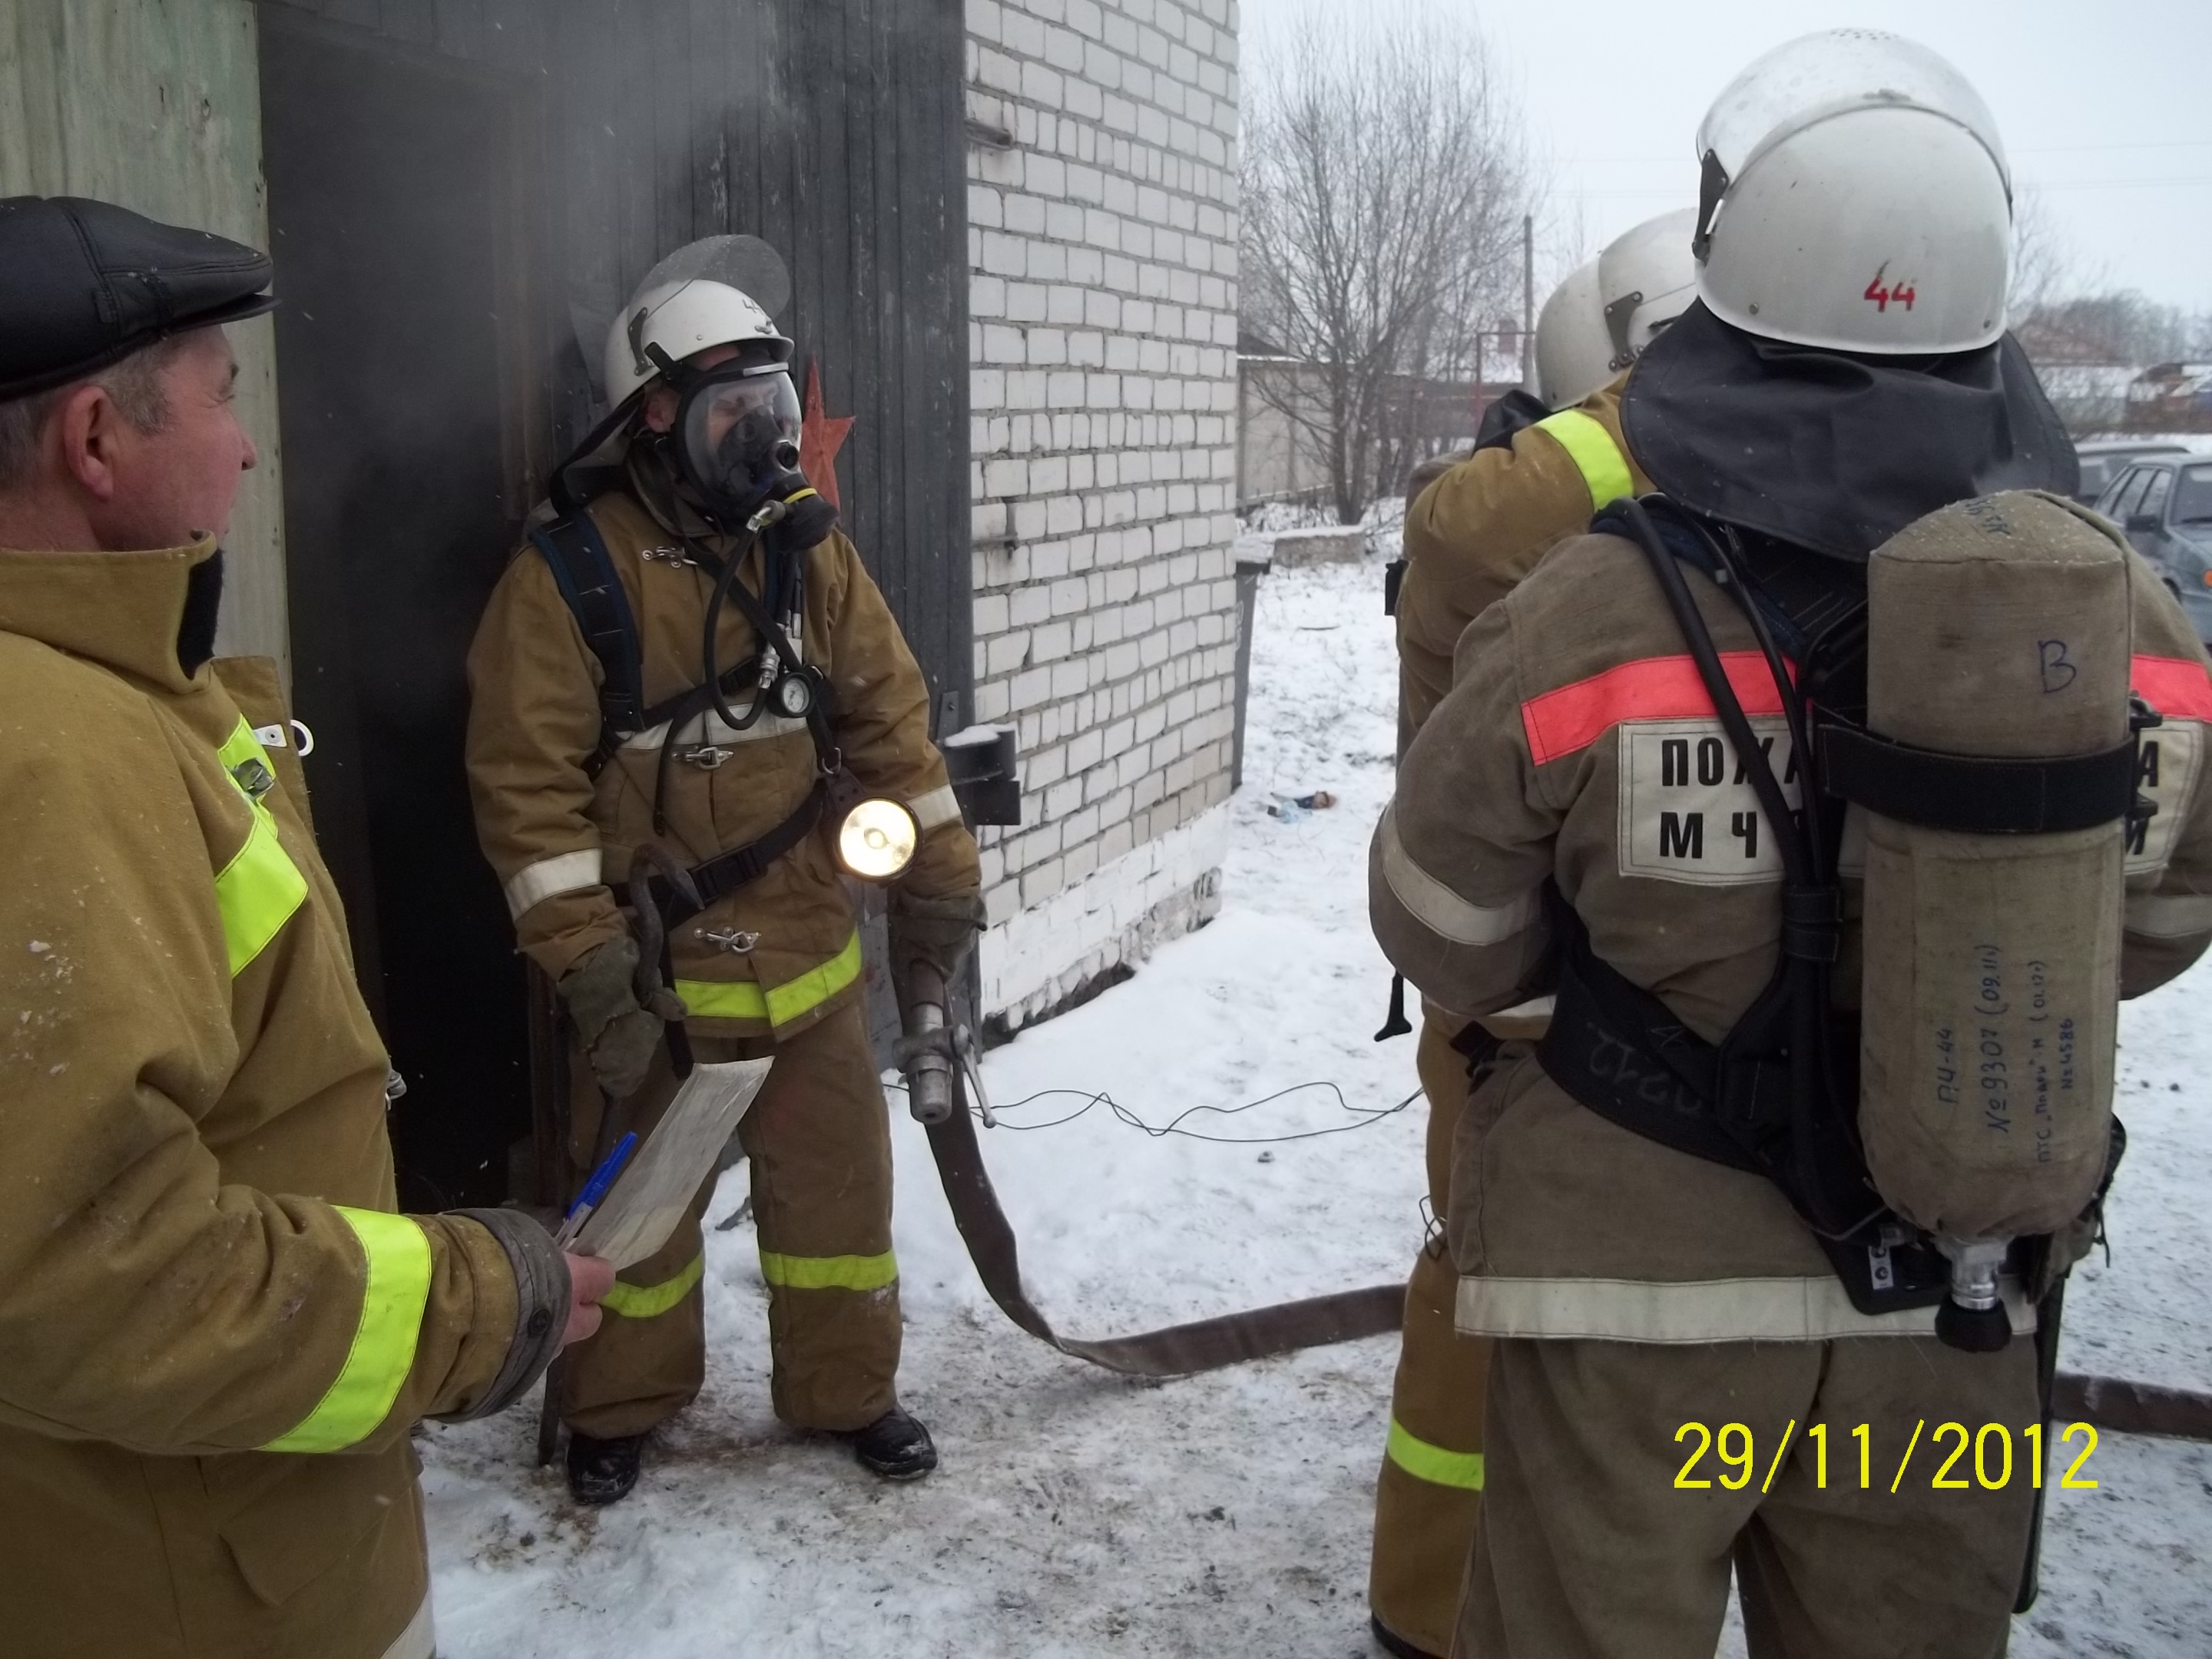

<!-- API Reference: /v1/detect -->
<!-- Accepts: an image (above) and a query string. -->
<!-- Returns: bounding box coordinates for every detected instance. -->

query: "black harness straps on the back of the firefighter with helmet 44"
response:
[1538,495,2157,1314]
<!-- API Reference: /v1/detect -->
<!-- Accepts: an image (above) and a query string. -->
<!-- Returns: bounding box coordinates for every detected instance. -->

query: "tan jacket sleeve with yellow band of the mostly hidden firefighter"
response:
[1398,376,1650,754]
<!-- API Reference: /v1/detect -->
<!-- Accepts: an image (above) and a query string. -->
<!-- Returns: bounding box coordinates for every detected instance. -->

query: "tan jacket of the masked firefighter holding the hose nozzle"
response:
[469,491,980,1035]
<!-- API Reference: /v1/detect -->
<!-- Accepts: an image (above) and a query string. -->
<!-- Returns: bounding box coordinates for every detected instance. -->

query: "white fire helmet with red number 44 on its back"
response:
[1692,28,2013,354]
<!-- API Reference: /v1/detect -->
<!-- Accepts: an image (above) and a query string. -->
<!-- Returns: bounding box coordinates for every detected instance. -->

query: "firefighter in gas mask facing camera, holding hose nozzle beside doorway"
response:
[469,239,982,1504]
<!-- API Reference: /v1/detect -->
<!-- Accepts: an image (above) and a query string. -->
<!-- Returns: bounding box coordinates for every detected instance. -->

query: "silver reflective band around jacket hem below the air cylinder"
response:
[1453,1274,2035,1343]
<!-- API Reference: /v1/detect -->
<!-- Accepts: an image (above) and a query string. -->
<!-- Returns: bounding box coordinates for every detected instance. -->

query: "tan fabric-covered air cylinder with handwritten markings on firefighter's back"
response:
[1858,493,2130,1349]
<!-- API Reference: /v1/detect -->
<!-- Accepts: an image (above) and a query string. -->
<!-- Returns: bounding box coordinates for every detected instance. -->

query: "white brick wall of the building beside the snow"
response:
[967,0,1237,1024]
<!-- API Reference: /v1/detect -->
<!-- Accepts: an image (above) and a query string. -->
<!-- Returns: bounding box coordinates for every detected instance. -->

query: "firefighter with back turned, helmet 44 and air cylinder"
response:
[1369,31,2212,1659]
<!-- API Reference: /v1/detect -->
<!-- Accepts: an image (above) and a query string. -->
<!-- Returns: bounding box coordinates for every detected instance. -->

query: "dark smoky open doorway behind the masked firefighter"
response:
[261,9,528,1207]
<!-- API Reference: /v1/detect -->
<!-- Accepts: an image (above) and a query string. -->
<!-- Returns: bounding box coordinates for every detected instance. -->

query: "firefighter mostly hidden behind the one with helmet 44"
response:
[1367,210,1694,1657]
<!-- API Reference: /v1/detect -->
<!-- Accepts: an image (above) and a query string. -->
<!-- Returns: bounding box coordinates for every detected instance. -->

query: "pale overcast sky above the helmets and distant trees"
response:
[1241,0,2212,312]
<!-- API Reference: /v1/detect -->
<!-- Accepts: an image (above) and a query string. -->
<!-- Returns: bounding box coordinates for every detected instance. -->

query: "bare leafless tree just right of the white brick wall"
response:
[1239,9,1528,525]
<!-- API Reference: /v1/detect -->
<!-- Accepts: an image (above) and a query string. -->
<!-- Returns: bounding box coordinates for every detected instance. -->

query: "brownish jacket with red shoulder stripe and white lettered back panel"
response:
[1369,499,2212,1340]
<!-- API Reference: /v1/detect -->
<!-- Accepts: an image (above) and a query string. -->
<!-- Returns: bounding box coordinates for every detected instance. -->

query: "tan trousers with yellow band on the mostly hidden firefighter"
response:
[1367,1008,1491,1654]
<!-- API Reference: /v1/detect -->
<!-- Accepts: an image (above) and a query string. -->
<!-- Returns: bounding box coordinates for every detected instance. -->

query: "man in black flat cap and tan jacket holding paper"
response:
[0,197,613,1659]
